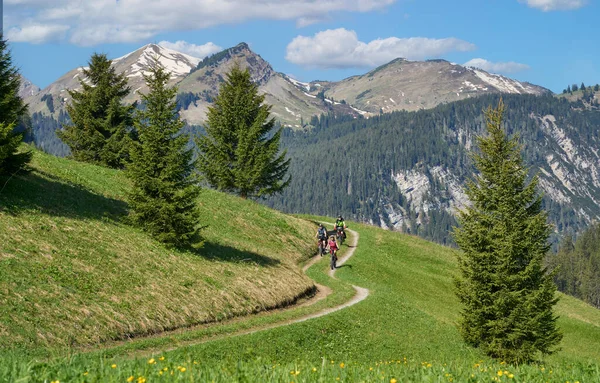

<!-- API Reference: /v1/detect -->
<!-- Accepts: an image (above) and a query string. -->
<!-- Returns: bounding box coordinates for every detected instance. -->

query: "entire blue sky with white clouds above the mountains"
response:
[4,0,600,92]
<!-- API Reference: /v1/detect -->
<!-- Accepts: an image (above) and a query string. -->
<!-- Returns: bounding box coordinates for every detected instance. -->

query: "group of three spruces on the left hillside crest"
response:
[58,54,289,246]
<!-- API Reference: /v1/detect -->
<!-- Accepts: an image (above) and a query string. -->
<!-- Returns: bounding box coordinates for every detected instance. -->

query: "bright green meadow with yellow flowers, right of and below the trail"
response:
[0,220,600,382]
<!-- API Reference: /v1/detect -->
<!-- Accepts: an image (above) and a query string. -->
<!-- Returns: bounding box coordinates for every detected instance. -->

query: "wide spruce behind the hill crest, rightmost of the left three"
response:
[196,65,290,198]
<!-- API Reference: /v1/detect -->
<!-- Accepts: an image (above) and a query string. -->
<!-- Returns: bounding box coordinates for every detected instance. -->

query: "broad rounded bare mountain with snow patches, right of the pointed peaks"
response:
[302,59,550,114]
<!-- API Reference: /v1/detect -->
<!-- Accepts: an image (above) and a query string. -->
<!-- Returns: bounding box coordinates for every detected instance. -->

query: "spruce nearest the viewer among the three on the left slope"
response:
[127,62,200,246]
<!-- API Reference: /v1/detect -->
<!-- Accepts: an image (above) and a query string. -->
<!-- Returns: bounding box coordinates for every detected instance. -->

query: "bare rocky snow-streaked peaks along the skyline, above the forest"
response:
[26,43,550,129]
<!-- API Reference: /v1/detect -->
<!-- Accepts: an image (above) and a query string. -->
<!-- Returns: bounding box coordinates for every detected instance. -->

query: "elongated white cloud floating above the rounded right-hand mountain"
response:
[285,28,475,68]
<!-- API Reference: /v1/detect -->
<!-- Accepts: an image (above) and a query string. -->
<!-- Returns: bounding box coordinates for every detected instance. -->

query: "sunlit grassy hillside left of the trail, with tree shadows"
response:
[0,148,314,350]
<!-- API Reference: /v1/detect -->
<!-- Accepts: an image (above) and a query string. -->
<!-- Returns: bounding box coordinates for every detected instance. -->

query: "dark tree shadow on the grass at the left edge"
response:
[0,171,127,220]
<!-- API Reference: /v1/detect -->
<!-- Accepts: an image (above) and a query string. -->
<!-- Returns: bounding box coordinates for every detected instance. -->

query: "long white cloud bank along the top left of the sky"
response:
[4,0,397,45]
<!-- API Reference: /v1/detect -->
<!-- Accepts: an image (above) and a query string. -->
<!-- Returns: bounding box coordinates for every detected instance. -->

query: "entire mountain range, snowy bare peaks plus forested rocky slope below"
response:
[19,43,600,242]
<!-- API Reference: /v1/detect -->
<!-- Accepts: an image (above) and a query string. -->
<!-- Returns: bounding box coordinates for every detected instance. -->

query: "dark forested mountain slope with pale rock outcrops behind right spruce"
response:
[267,95,600,243]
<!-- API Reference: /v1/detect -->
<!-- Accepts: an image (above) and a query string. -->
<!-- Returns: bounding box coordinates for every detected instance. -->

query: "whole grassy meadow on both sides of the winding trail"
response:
[0,153,600,383]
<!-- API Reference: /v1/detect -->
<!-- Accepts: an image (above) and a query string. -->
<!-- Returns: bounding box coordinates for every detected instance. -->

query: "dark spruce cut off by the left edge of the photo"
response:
[0,34,31,174]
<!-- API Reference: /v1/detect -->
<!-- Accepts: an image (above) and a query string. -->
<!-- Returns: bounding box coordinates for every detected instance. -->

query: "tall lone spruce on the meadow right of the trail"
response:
[454,100,562,363]
